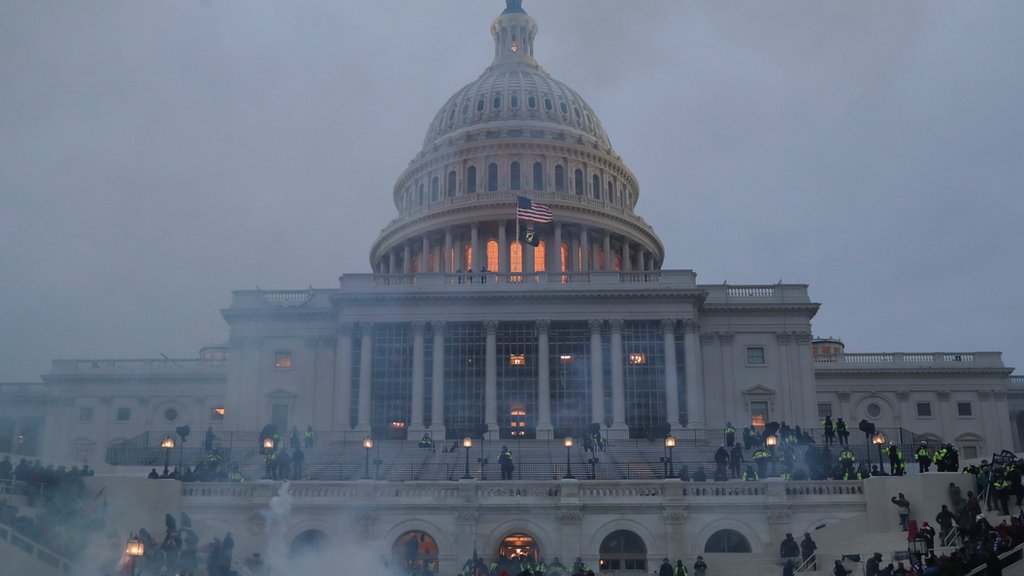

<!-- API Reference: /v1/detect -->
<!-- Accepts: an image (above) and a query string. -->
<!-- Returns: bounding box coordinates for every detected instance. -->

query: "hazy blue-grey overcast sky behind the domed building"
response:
[0,0,1024,381]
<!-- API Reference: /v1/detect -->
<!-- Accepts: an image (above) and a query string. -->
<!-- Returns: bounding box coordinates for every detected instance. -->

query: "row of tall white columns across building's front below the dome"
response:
[335,319,703,440]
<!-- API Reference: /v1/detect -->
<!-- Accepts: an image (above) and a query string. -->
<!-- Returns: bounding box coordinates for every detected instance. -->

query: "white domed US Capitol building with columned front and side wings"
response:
[0,1,1024,574]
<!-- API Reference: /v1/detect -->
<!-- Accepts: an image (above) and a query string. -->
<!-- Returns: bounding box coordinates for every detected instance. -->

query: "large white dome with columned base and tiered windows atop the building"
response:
[370,0,665,275]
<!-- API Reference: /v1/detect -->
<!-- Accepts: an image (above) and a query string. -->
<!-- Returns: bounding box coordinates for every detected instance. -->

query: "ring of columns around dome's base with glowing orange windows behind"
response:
[374,220,660,274]
